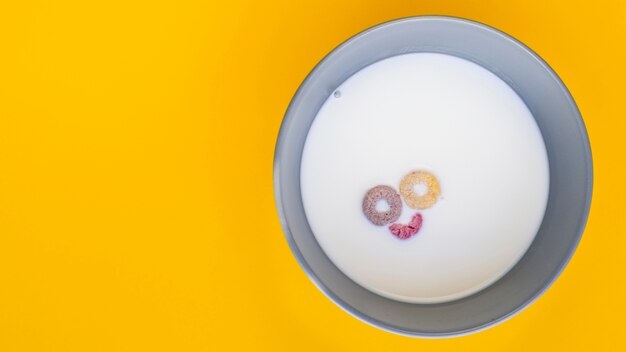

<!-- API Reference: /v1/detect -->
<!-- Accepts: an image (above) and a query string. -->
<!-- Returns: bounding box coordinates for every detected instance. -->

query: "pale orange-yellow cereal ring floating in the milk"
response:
[400,170,441,209]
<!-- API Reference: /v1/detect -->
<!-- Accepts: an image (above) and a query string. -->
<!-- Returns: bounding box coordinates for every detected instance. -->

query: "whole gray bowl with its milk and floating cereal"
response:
[274,16,593,337]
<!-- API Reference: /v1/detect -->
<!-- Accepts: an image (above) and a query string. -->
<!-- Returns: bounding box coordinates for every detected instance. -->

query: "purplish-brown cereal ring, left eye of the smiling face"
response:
[363,185,402,226]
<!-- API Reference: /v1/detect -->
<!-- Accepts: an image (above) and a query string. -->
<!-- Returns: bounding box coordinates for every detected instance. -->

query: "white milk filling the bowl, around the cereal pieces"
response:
[301,53,549,303]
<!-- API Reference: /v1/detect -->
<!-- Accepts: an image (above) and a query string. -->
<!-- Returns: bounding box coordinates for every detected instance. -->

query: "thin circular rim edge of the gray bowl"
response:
[273,15,593,338]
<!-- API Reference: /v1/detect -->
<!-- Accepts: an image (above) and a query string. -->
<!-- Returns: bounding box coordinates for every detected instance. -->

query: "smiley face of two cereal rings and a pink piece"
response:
[363,170,441,240]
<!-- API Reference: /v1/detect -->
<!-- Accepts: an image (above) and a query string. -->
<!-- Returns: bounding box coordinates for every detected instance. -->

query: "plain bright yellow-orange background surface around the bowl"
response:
[0,0,626,351]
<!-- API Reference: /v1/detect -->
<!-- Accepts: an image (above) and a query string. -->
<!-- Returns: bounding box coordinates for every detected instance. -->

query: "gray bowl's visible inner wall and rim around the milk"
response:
[274,16,593,337]
